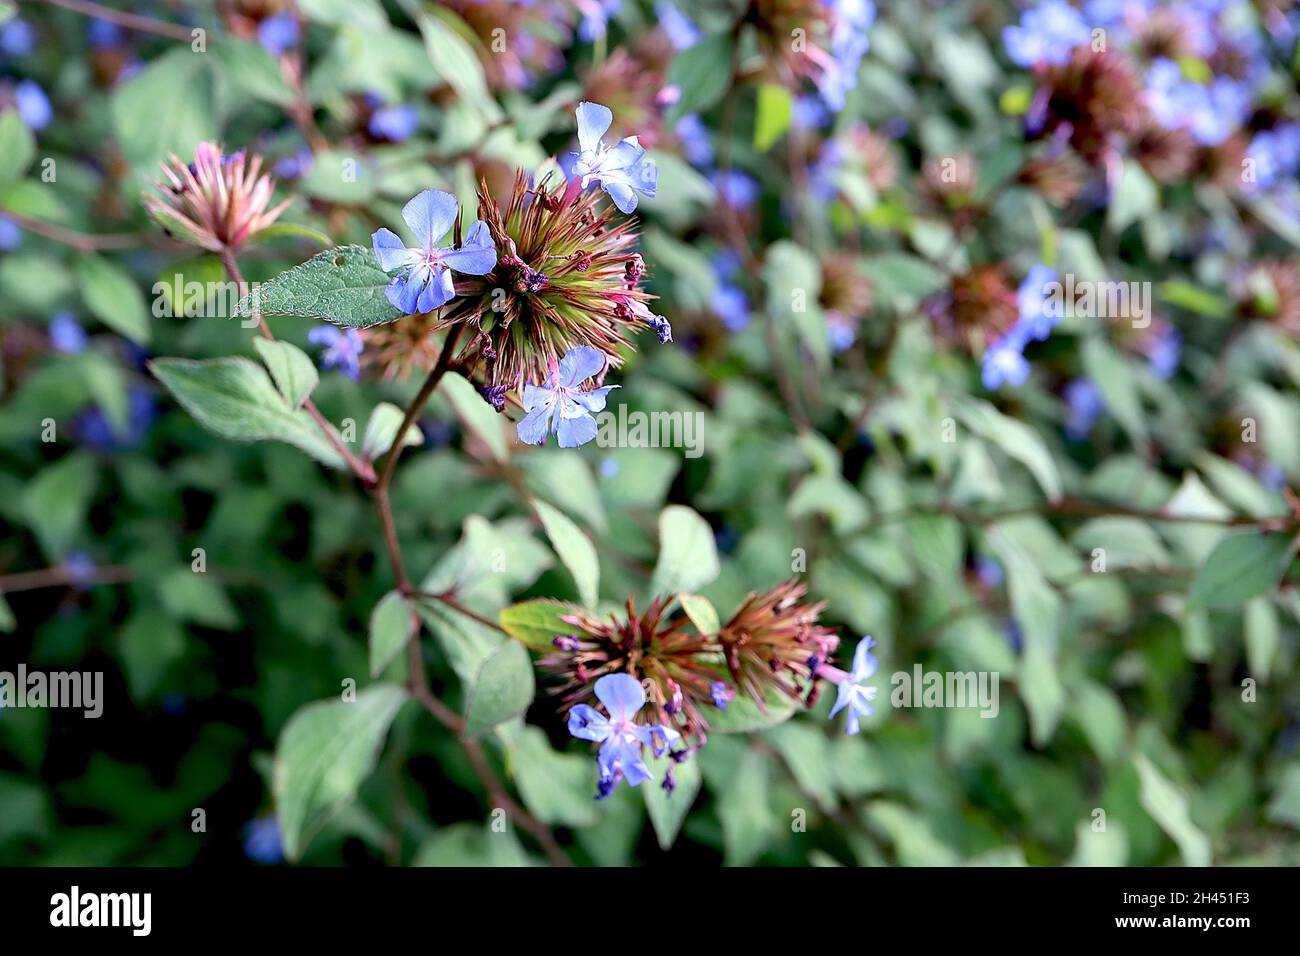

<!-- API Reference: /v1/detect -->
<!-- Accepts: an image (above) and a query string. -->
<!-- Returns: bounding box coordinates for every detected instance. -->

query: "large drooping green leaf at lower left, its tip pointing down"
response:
[272,684,407,861]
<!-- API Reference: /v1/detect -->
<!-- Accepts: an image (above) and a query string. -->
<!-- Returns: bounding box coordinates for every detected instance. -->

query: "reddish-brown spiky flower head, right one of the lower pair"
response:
[718,581,840,710]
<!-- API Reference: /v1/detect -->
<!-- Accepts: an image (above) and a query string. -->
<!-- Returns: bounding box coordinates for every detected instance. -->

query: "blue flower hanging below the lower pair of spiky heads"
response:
[568,674,681,797]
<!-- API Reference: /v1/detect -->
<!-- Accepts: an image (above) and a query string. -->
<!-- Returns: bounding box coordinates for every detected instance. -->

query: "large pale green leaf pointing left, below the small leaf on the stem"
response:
[150,356,345,468]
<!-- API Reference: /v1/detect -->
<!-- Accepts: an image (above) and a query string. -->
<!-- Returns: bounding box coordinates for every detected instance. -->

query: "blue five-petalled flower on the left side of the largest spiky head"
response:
[371,189,497,315]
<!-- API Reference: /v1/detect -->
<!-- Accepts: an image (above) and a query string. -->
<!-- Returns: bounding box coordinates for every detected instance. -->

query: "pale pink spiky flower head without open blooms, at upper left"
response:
[144,143,291,252]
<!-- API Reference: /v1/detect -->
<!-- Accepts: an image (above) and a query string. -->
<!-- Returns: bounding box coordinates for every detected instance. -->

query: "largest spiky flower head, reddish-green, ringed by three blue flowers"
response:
[442,173,654,389]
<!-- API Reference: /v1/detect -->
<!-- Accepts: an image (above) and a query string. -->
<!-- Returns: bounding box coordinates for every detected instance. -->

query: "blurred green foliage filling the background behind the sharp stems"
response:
[0,0,1300,865]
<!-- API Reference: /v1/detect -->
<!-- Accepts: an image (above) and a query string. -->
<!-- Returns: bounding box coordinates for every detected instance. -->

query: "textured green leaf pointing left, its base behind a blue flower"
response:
[235,246,402,329]
